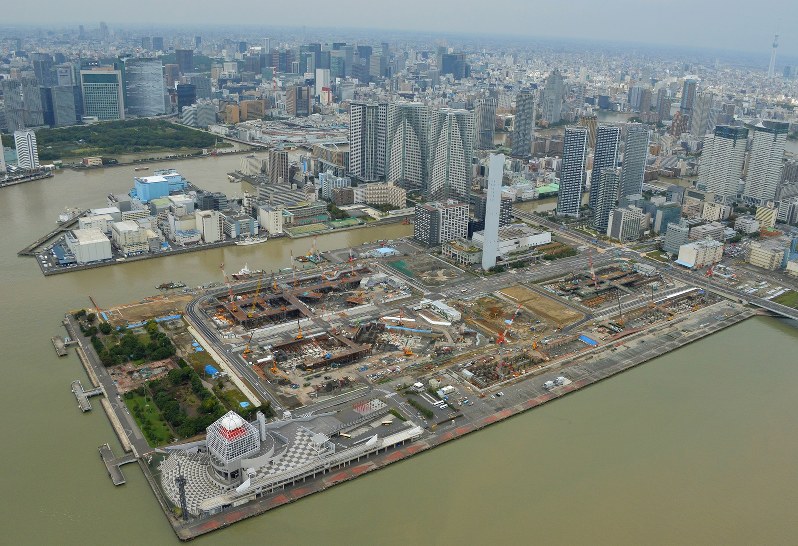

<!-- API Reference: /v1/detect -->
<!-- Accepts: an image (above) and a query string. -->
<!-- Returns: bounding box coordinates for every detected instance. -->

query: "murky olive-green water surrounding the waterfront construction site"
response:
[0,157,798,545]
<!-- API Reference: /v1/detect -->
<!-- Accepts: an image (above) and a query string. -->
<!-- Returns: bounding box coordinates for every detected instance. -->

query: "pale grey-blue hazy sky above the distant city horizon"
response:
[7,0,798,56]
